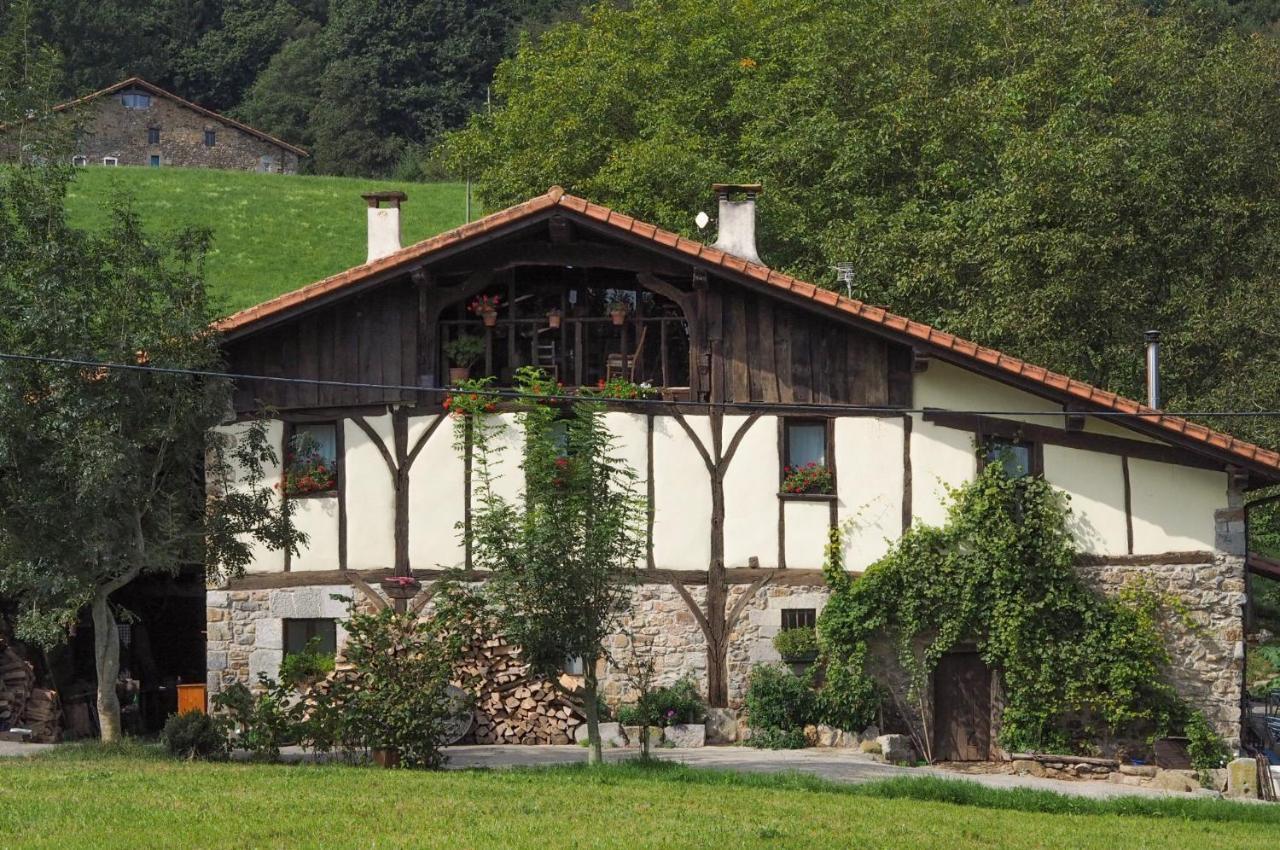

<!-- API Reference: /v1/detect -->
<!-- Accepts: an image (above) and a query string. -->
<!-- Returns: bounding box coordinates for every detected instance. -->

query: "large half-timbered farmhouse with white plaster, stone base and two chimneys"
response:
[206,186,1280,759]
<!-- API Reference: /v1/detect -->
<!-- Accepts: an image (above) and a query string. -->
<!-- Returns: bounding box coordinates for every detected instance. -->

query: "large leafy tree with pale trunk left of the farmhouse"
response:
[0,159,300,741]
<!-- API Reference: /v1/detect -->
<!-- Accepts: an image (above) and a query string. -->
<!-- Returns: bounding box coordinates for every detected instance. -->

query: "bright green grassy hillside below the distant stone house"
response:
[68,168,466,312]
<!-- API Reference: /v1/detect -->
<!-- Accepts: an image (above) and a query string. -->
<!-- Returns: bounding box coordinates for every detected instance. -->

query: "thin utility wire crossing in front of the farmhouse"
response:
[0,352,1280,419]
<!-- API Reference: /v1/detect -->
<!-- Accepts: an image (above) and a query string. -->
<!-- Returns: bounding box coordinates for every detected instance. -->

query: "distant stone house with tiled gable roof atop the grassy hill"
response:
[47,77,307,174]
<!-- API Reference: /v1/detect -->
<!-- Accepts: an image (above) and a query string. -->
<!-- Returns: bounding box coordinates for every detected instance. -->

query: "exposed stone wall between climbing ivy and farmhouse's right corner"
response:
[1079,554,1245,748]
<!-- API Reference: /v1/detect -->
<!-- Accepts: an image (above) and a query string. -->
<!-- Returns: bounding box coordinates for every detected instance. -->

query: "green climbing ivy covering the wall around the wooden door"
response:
[818,463,1185,755]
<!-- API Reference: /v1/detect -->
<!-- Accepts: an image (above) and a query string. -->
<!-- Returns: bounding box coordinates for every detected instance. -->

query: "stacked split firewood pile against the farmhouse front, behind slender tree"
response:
[460,638,584,744]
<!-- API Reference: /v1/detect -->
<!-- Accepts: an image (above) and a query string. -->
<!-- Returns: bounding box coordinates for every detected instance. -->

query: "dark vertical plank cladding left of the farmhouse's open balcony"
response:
[227,279,419,411]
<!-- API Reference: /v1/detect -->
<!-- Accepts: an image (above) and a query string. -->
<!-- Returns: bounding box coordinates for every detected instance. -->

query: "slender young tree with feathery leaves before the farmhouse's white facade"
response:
[452,367,645,763]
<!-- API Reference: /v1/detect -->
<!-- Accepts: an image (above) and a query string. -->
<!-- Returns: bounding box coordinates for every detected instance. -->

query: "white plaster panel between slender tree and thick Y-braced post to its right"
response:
[653,416,716,570]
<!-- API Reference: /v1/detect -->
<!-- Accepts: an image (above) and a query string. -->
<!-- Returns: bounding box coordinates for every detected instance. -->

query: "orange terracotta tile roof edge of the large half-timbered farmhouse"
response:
[215,186,1280,472]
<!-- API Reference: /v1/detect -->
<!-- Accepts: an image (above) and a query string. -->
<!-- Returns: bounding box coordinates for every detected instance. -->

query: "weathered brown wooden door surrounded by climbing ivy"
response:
[933,653,991,762]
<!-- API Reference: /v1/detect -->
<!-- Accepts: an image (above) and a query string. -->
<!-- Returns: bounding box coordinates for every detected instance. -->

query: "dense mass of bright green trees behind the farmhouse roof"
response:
[443,0,1280,442]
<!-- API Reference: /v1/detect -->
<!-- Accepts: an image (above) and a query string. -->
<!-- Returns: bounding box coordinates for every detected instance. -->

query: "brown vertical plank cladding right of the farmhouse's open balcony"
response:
[703,282,911,407]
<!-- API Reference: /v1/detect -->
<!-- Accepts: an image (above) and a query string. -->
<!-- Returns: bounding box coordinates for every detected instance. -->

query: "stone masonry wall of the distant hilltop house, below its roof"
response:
[74,92,298,174]
